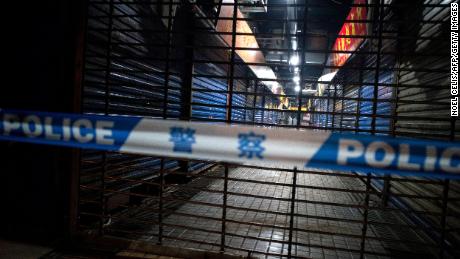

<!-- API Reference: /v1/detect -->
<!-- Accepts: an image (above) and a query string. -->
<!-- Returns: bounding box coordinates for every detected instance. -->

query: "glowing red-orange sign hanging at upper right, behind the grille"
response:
[329,0,367,67]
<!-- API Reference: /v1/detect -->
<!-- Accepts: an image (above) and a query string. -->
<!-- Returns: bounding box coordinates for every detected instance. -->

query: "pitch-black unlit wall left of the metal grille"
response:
[0,0,85,243]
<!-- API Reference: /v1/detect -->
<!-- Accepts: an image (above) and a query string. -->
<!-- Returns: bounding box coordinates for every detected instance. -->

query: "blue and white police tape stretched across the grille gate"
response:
[0,109,460,179]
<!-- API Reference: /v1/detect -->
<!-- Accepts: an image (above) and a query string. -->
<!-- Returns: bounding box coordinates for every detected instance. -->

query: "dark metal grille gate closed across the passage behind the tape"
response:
[78,0,460,258]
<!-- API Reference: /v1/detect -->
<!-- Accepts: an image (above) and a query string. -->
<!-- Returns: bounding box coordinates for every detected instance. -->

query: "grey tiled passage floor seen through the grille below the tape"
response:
[108,167,434,258]
